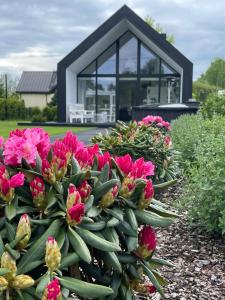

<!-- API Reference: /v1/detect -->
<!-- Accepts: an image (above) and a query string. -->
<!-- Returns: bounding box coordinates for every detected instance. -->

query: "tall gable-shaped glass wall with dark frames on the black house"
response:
[77,31,180,122]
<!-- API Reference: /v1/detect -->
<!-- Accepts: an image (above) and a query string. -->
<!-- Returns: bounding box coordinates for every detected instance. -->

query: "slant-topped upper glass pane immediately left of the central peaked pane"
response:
[98,44,116,74]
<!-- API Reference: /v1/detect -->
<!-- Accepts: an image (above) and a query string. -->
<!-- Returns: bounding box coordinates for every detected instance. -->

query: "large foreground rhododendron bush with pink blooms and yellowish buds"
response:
[0,128,175,300]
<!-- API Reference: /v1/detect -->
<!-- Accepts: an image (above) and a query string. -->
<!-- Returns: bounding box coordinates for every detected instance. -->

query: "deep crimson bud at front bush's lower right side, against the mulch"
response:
[136,226,157,259]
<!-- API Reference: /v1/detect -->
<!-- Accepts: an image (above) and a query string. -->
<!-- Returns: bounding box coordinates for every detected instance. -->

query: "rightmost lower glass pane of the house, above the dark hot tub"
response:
[160,77,180,104]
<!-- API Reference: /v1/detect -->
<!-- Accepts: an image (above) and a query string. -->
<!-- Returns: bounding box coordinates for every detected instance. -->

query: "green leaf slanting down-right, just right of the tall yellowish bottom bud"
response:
[68,227,91,263]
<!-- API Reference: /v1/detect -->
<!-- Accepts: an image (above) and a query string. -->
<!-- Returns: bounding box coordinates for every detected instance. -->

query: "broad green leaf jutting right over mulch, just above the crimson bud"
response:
[135,210,174,227]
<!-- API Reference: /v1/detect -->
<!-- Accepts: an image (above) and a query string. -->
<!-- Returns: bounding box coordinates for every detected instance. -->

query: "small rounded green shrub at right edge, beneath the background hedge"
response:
[201,95,225,118]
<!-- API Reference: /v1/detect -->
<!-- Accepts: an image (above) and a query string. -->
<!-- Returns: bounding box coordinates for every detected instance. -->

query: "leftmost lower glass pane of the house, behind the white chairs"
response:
[78,77,95,111]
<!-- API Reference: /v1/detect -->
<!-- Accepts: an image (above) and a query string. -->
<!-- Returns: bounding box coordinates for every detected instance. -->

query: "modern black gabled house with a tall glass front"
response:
[57,5,196,123]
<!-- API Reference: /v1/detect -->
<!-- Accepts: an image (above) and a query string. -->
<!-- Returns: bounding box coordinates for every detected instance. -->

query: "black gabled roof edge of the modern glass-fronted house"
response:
[58,5,192,68]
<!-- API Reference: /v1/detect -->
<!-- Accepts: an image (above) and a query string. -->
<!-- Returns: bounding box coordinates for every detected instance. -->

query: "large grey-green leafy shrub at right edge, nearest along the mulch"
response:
[181,133,225,234]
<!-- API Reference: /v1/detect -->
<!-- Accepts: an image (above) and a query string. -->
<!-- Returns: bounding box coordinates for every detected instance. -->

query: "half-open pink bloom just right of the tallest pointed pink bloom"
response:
[75,144,99,168]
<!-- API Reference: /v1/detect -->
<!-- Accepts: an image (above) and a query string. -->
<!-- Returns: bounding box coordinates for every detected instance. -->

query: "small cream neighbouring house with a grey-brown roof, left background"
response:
[16,71,57,109]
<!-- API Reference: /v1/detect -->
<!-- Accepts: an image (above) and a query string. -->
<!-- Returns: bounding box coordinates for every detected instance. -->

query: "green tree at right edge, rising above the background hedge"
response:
[199,58,225,89]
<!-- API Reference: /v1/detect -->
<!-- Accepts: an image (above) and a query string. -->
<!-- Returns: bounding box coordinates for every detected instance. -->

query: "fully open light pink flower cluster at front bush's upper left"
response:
[3,128,51,167]
